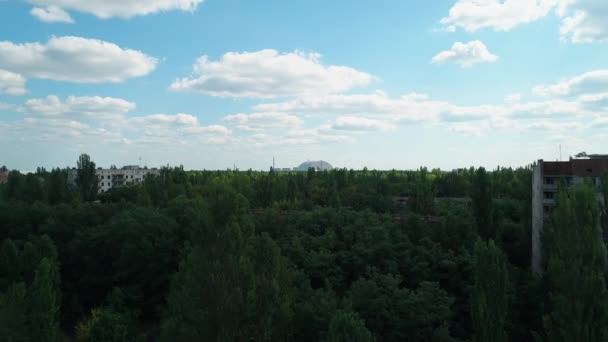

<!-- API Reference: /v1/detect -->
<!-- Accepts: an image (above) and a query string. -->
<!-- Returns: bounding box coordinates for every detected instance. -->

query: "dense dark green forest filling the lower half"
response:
[0,156,608,342]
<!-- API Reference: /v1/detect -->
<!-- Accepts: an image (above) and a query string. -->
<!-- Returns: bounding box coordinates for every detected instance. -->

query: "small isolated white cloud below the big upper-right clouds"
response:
[432,40,498,68]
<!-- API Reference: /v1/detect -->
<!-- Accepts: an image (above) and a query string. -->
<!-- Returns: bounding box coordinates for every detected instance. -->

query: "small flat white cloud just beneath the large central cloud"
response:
[224,112,304,131]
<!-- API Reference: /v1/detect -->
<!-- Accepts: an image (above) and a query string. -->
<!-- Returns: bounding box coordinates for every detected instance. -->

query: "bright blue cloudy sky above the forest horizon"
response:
[0,0,608,170]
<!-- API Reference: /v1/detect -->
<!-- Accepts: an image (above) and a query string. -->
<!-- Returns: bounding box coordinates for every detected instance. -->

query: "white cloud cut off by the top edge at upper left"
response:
[27,0,203,19]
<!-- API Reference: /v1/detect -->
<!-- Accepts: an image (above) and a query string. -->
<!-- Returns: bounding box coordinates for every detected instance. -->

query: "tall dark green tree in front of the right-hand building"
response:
[544,184,608,342]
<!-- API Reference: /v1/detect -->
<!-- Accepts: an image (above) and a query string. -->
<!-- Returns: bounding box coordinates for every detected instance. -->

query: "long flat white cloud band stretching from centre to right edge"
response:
[245,85,608,138]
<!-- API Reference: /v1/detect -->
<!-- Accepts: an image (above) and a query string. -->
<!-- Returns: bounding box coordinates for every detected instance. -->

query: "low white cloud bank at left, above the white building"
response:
[9,95,233,145]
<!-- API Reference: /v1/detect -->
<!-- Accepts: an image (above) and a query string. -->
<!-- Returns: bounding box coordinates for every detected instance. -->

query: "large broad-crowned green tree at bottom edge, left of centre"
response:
[161,212,290,341]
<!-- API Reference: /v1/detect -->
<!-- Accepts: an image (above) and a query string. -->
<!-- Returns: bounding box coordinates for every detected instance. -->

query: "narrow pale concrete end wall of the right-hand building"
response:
[532,160,544,274]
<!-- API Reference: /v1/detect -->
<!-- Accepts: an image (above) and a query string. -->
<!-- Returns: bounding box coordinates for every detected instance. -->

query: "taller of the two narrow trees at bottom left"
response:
[28,258,61,342]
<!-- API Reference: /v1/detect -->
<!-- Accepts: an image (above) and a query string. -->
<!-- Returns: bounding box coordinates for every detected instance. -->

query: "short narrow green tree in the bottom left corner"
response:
[0,283,30,342]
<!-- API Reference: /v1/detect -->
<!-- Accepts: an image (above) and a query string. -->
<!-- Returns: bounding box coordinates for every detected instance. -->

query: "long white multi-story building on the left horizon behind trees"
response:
[68,165,160,193]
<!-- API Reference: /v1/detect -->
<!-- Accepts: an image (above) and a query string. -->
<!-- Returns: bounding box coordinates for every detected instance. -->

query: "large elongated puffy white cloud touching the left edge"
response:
[0,36,158,83]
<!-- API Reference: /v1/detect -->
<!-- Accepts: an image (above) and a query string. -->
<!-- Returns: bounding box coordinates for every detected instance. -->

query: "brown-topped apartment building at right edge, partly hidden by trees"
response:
[532,154,608,274]
